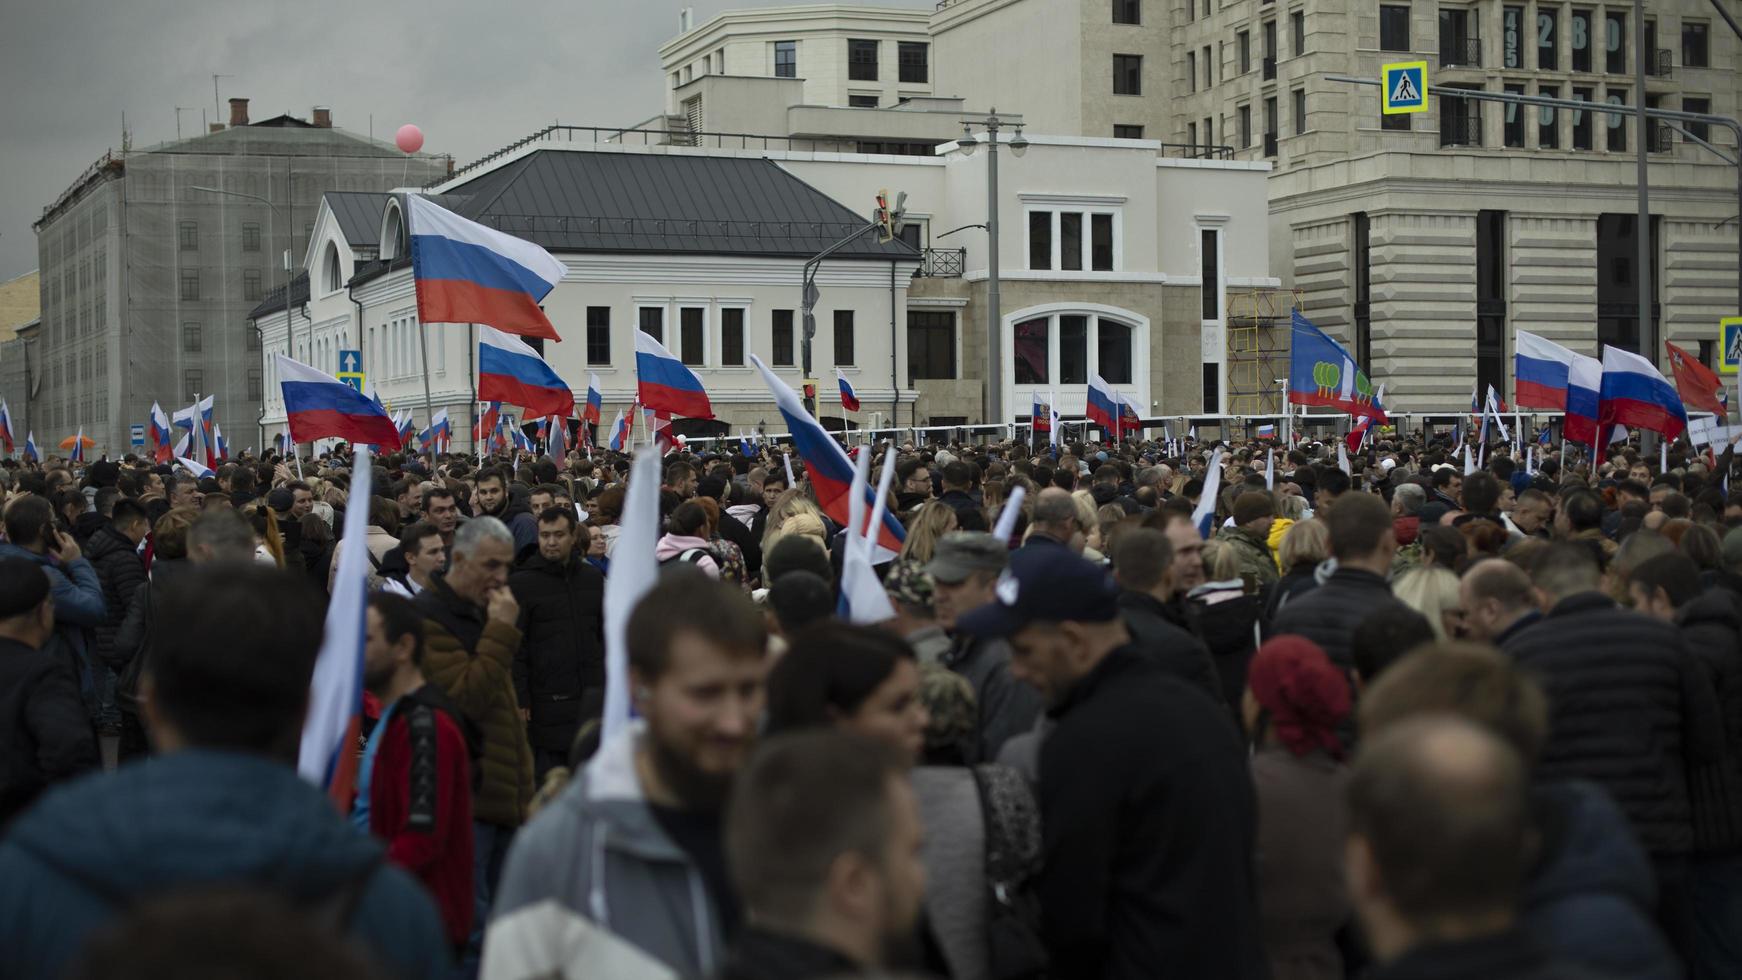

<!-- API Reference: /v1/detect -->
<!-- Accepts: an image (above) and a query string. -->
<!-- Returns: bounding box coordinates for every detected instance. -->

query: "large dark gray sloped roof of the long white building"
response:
[444,150,918,261]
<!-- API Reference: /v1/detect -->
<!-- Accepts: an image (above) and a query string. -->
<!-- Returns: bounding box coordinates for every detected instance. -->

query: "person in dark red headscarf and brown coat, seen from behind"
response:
[1240,635,1350,980]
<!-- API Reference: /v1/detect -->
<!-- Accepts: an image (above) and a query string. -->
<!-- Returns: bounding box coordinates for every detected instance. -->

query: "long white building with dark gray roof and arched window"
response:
[254,132,1275,446]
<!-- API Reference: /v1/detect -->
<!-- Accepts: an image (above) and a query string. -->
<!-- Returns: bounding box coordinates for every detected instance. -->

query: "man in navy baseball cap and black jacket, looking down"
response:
[958,548,1266,980]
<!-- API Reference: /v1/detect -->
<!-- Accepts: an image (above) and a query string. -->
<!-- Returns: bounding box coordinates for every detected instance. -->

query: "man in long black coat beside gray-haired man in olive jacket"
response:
[509,507,604,783]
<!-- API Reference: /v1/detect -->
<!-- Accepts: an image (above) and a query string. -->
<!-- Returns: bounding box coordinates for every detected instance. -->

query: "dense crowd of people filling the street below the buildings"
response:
[0,433,1742,980]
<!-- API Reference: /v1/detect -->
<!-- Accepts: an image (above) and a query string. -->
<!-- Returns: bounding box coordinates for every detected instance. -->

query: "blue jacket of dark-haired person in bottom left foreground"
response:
[0,750,449,980]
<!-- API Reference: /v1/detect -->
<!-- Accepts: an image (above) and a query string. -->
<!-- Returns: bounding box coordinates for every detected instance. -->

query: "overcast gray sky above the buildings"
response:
[0,0,934,282]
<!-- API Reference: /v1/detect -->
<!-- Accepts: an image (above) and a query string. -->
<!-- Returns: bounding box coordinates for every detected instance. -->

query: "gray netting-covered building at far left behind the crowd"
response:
[23,99,449,454]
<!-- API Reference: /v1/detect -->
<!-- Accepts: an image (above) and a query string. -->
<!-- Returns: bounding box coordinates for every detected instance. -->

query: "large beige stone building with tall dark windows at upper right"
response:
[930,0,1742,411]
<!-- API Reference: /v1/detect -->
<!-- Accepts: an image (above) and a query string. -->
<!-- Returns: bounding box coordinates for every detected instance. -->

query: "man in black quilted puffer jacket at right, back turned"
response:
[1503,541,1723,952]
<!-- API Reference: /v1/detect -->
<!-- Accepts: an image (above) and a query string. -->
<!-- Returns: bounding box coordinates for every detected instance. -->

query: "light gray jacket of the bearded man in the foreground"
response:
[486,722,725,977]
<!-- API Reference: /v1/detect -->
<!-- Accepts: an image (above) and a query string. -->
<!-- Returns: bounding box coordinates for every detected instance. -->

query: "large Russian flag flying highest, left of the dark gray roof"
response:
[404,195,566,339]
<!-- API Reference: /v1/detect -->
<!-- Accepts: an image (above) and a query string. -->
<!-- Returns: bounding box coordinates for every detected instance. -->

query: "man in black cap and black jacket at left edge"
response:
[0,559,99,832]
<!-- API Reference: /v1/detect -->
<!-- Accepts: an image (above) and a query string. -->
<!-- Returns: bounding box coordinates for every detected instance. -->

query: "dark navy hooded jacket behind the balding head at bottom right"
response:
[1519,780,1681,980]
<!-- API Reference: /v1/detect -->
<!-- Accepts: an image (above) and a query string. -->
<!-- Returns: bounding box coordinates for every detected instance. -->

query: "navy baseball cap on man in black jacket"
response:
[956,548,1118,639]
